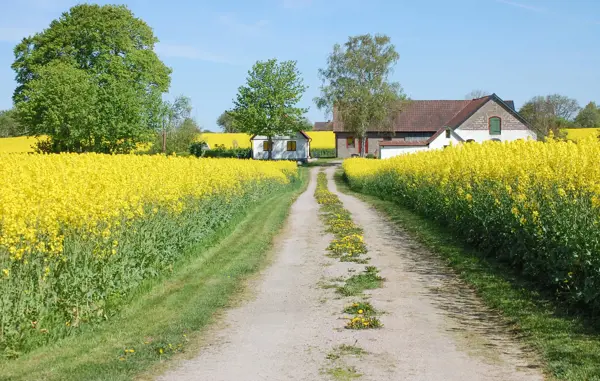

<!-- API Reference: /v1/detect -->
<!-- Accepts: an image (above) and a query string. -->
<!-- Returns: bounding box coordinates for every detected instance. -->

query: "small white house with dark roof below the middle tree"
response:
[250,131,311,162]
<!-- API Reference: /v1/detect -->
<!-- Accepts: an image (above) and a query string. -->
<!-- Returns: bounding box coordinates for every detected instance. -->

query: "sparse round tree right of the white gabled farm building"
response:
[519,94,579,138]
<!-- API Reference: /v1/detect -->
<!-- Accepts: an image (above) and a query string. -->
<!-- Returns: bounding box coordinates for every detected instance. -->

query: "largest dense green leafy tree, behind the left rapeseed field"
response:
[12,4,171,152]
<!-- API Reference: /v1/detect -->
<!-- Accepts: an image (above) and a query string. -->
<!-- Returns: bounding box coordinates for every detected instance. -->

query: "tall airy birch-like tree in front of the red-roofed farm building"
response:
[315,34,406,155]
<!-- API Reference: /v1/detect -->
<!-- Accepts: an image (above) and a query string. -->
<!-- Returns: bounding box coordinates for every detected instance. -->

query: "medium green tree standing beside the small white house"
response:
[232,59,307,160]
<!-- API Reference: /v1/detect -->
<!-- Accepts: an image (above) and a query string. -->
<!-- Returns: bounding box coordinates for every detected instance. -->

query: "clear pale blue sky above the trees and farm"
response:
[0,0,600,130]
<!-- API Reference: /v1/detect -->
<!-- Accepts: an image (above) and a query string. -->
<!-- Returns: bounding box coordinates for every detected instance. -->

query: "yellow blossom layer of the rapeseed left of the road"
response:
[0,154,295,260]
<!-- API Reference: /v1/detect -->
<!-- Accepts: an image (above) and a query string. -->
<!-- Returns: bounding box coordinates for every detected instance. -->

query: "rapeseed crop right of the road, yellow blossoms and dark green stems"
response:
[343,139,600,311]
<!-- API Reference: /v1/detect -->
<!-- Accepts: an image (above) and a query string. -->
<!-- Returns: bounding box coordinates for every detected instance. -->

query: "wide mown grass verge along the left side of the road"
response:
[0,169,307,381]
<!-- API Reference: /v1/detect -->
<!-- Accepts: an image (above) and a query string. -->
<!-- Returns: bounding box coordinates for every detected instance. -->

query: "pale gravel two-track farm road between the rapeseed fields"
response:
[159,168,543,381]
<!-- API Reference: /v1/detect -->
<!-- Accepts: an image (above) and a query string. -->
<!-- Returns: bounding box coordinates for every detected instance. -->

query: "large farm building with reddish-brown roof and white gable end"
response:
[326,94,536,159]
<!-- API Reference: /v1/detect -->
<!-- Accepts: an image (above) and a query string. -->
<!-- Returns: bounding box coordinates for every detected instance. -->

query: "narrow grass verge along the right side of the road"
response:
[335,171,600,381]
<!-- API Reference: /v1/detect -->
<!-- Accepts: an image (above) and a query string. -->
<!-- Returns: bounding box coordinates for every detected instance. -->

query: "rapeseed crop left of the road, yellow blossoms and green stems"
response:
[0,154,297,350]
